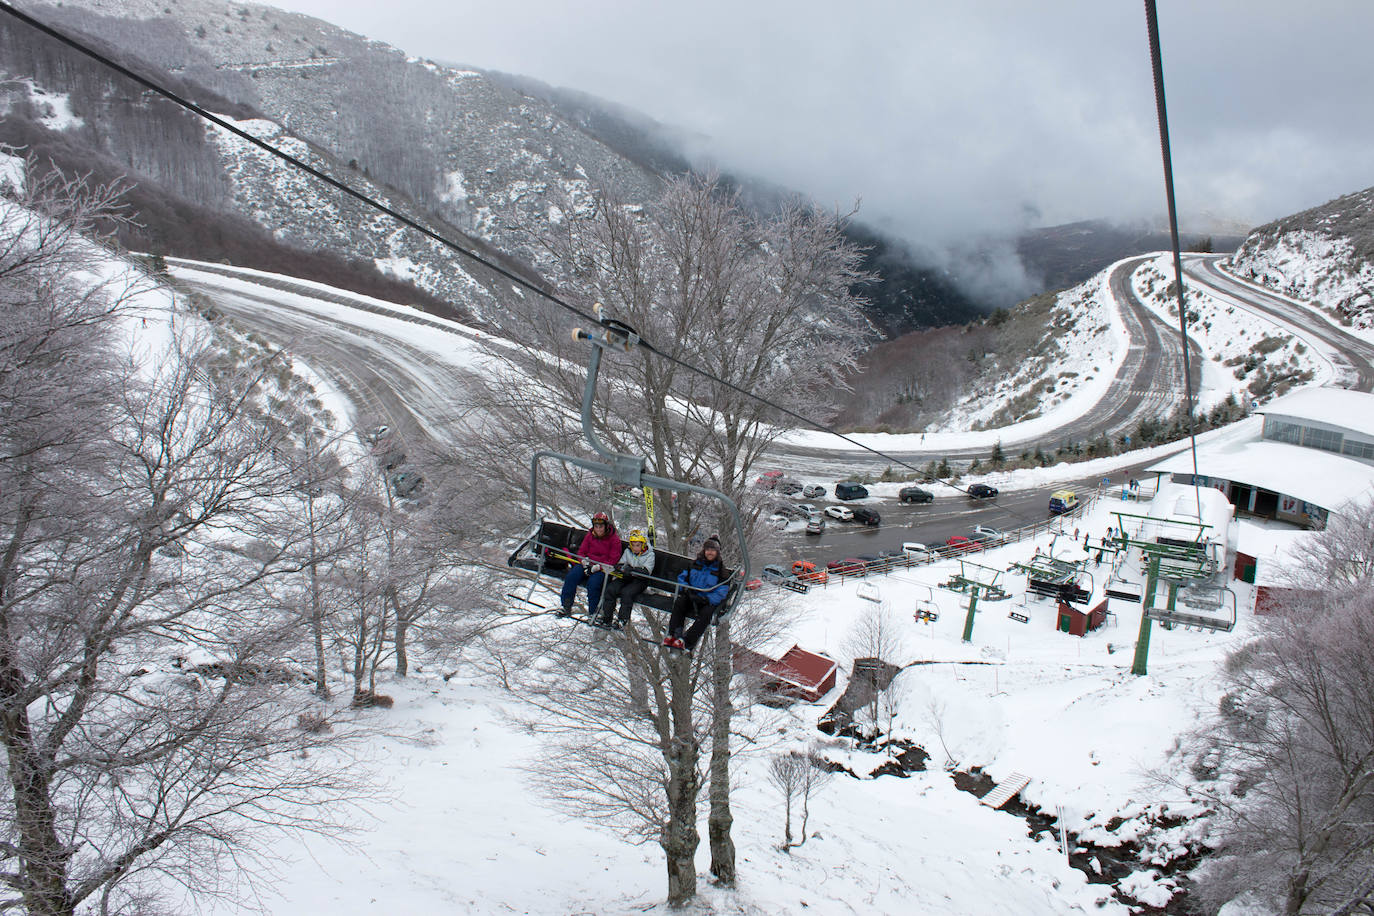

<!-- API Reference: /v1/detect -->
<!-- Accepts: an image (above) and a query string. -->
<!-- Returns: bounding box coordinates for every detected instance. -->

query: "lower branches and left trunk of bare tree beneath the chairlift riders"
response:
[505,585,780,905]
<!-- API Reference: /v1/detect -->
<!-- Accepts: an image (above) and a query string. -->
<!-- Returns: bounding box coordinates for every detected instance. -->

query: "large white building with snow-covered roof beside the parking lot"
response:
[1149,387,1374,527]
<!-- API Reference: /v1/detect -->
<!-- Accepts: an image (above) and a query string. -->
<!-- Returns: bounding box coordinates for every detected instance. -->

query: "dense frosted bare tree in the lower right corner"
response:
[1191,507,1374,916]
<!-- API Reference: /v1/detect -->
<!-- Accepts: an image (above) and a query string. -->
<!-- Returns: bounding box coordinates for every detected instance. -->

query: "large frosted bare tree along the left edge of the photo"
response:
[0,168,368,915]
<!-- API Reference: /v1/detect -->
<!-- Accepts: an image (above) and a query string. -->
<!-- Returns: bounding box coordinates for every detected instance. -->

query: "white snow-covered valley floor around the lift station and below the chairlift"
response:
[26,233,1357,916]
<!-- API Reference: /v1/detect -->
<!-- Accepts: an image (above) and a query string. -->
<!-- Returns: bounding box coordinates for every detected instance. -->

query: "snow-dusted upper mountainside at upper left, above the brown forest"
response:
[12,0,658,324]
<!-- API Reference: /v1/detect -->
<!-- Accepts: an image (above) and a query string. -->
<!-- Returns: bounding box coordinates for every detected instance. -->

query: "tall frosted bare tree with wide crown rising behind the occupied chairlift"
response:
[473,176,871,884]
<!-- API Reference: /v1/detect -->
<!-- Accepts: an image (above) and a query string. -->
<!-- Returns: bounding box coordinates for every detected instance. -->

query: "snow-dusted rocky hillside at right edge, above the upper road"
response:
[1227,188,1374,330]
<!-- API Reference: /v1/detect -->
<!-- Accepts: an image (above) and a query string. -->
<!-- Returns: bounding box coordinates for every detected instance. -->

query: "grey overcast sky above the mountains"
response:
[262,0,1374,258]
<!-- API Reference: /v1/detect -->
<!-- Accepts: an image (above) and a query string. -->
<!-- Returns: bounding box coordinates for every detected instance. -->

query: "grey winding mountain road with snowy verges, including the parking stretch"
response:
[169,248,1374,559]
